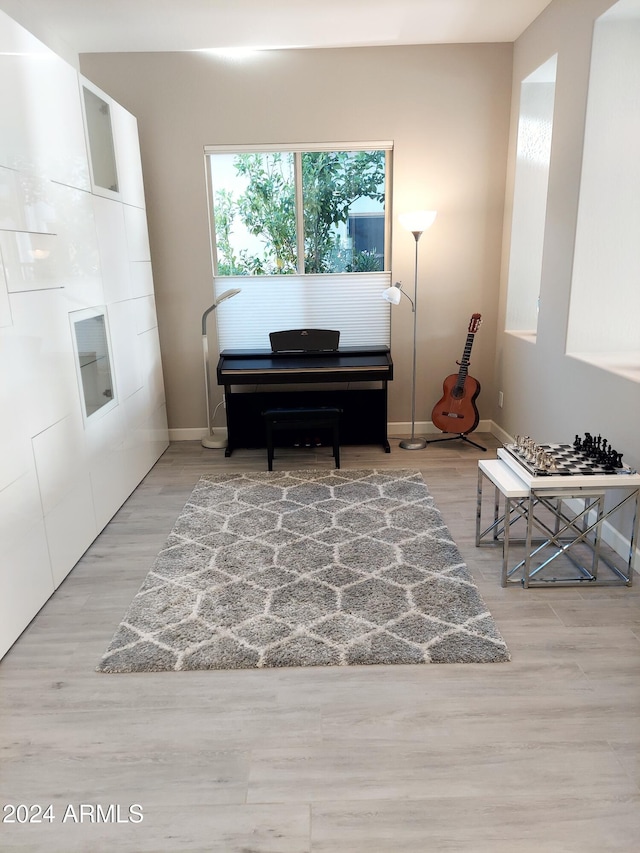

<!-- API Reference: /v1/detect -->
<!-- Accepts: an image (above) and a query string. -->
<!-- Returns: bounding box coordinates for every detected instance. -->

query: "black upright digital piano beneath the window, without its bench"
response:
[217,329,393,456]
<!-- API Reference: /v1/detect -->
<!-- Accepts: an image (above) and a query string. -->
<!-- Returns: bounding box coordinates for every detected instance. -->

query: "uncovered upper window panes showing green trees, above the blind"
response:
[207,143,389,276]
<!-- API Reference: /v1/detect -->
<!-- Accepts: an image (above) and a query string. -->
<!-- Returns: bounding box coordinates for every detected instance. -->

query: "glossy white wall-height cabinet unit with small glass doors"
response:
[0,12,168,656]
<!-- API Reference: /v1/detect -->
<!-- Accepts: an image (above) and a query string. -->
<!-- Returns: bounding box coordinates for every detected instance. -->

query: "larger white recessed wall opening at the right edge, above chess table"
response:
[566,0,640,382]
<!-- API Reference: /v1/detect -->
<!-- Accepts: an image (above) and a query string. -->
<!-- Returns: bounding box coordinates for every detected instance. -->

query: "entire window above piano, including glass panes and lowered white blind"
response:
[205,142,392,350]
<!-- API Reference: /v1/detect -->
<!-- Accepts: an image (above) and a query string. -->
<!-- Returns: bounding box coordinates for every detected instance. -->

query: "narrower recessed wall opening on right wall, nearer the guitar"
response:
[506,55,557,340]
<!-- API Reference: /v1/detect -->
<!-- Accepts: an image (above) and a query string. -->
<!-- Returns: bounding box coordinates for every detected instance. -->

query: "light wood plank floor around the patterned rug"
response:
[0,435,640,853]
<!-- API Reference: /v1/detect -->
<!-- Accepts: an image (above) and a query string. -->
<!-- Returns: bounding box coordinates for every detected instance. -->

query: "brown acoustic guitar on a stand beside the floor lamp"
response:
[431,314,480,435]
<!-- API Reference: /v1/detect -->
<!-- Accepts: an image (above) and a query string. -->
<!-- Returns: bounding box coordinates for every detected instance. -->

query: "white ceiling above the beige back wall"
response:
[11,0,551,53]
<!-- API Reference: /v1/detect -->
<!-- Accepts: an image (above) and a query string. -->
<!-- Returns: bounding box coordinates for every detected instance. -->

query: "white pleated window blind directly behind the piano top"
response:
[214,272,391,351]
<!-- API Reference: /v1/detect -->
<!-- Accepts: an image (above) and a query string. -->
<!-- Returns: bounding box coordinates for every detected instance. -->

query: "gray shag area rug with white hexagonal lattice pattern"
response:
[98,469,510,672]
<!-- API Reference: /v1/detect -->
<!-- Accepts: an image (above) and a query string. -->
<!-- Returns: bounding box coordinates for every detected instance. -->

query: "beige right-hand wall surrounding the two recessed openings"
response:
[496,0,640,467]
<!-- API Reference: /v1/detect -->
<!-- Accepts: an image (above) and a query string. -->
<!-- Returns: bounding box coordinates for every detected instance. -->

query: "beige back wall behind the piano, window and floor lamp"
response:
[80,44,512,430]
